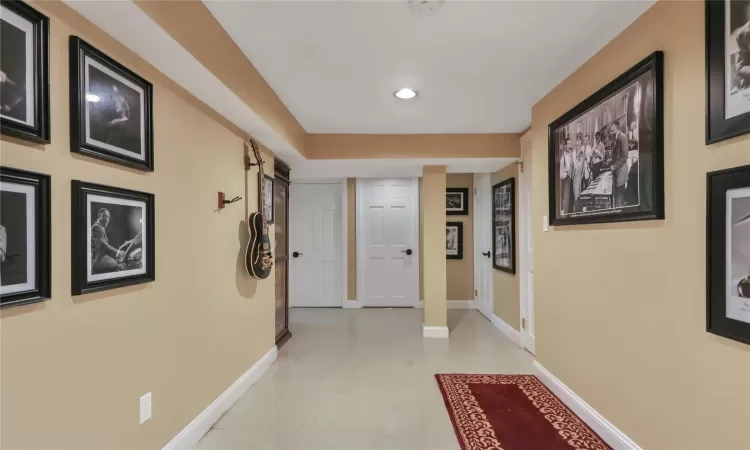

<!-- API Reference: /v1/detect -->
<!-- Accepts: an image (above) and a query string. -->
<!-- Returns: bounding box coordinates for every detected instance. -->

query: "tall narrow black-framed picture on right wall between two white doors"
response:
[492,178,516,274]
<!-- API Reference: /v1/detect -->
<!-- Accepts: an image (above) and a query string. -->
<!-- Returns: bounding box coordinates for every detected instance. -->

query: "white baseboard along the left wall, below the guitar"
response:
[163,345,278,450]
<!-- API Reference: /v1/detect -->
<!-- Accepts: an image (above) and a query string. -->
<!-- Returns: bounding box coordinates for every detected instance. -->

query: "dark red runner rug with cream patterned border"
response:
[435,374,612,450]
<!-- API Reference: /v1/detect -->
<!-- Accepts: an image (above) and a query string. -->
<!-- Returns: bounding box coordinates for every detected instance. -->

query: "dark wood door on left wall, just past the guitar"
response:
[273,160,292,347]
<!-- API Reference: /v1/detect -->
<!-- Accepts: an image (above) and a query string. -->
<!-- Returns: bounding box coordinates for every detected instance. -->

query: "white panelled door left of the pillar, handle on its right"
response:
[357,179,419,307]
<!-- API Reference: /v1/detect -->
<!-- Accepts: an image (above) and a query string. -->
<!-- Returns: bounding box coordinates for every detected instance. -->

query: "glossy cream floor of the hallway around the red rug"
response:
[197,309,533,450]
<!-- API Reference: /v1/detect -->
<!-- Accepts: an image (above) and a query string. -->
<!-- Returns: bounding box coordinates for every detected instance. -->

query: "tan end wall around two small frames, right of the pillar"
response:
[443,173,474,300]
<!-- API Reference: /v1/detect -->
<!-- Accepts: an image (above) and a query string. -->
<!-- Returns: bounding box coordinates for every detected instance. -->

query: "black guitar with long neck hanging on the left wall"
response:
[245,139,273,280]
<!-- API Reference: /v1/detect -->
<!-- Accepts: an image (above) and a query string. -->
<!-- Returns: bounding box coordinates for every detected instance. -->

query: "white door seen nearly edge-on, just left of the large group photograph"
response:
[518,148,536,354]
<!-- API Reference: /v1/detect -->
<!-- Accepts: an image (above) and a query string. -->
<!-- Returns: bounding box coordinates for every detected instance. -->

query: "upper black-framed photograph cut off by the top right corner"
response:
[706,0,750,144]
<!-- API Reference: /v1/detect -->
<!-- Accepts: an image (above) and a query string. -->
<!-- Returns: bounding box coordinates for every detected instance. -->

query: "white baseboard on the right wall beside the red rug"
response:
[534,361,642,450]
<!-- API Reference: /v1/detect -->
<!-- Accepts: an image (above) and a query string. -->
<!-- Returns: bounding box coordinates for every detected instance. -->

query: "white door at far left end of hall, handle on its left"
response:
[289,183,344,307]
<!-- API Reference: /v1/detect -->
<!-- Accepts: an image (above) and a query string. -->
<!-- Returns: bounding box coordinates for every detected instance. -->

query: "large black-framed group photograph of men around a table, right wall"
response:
[547,51,664,226]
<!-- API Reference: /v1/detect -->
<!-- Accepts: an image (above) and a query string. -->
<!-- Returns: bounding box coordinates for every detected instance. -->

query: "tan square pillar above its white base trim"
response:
[422,166,448,326]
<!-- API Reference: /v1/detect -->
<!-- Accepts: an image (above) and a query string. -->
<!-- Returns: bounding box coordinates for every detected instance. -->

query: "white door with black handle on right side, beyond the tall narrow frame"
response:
[474,173,494,320]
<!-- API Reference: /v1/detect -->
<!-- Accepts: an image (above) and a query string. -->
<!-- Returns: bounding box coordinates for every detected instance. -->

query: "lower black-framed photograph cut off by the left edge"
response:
[0,167,50,307]
